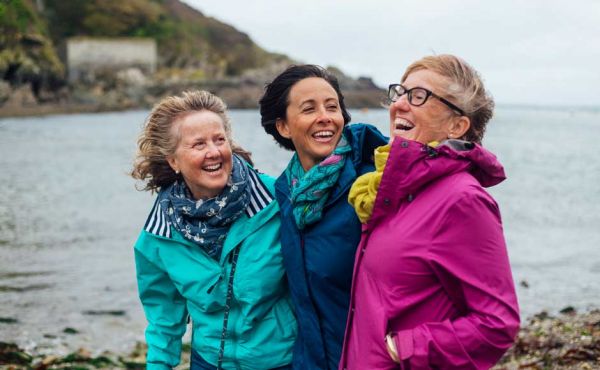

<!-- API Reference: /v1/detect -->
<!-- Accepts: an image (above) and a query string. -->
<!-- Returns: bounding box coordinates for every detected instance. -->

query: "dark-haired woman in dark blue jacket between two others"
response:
[260,65,387,369]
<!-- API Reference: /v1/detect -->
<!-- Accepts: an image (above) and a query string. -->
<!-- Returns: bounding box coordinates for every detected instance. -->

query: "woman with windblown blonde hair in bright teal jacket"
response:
[132,91,296,370]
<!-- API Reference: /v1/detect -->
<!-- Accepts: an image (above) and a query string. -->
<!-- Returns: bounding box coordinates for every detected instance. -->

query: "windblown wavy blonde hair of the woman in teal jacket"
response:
[131,90,252,191]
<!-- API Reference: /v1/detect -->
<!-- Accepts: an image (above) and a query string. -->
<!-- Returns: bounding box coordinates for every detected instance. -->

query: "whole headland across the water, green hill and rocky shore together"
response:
[0,0,382,116]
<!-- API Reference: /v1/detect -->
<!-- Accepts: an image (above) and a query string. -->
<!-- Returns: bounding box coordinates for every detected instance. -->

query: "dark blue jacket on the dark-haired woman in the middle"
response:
[275,124,387,370]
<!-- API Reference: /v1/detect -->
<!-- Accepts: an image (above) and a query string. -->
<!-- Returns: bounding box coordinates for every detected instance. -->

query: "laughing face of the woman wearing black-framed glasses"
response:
[389,69,469,144]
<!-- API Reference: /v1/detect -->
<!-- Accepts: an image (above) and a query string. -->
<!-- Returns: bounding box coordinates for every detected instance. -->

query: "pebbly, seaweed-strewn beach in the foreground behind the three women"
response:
[0,307,600,370]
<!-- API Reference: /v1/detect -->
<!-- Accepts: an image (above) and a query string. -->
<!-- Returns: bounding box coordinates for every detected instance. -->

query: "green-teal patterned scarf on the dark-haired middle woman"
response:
[285,135,352,230]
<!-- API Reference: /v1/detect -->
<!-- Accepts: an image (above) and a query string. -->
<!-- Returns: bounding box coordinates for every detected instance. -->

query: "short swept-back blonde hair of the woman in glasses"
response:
[402,54,494,143]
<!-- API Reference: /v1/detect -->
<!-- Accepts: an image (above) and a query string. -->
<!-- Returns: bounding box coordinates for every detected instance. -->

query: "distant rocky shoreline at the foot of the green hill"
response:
[0,64,385,118]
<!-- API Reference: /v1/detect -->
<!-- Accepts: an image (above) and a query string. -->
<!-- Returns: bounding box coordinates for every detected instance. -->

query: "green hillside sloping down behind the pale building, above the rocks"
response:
[0,0,287,86]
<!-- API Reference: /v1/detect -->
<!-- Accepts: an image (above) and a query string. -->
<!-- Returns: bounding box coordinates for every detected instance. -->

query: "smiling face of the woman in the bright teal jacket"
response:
[168,110,232,199]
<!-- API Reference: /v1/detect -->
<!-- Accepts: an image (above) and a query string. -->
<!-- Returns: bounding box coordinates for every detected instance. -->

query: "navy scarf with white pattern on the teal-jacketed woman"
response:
[158,155,251,261]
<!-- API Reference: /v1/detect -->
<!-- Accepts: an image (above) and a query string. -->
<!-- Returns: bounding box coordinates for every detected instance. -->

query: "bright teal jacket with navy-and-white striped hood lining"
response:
[135,170,297,369]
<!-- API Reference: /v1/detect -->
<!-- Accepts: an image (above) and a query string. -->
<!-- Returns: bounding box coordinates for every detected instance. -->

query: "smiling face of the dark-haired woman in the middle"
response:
[276,77,344,171]
